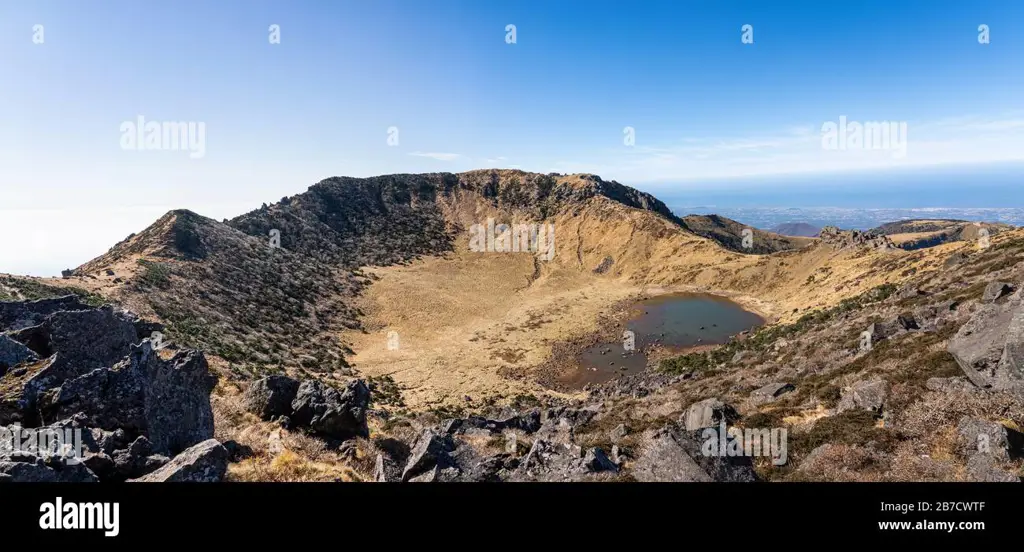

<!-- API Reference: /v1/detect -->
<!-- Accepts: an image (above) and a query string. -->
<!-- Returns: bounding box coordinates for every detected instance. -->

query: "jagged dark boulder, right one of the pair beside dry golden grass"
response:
[292,380,370,439]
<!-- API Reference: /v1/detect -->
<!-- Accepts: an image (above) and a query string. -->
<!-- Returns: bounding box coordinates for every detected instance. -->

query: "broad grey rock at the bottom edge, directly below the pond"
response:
[632,427,757,482]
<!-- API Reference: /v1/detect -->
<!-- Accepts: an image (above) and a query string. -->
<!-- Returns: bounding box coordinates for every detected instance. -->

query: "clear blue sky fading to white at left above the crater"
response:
[0,0,1024,274]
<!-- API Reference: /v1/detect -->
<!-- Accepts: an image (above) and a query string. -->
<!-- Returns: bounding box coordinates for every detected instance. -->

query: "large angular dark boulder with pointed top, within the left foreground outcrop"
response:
[40,340,216,456]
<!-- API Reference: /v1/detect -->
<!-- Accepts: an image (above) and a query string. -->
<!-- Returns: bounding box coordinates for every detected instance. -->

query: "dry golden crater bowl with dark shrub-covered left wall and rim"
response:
[51,170,941,406]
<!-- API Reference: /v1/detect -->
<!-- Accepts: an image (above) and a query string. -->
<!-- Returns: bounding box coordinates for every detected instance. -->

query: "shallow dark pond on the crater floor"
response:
[562,293,765,388]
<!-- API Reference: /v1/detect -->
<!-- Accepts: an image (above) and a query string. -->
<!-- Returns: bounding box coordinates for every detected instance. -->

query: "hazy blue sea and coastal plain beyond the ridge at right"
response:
[638,163,1024,229]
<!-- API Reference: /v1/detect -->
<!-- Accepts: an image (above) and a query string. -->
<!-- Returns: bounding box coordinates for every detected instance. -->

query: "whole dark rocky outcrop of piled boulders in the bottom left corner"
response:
[0,298,222,481]
